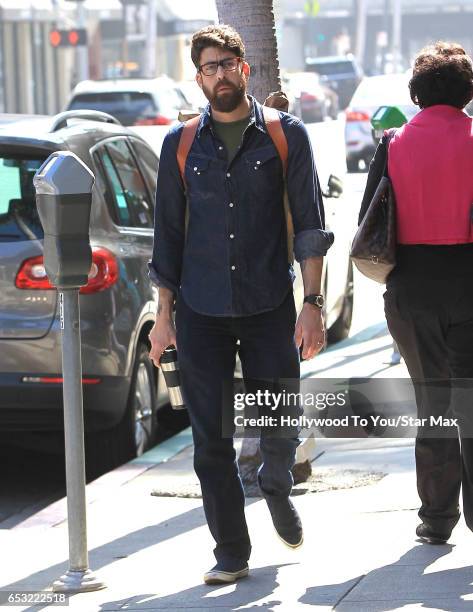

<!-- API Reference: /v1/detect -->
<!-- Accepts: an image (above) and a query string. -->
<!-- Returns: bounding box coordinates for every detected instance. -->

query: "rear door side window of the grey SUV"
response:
[100,140,153,227]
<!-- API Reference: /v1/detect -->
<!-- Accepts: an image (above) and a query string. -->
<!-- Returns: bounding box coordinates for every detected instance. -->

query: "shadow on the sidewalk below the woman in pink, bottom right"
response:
[299,544,473,612]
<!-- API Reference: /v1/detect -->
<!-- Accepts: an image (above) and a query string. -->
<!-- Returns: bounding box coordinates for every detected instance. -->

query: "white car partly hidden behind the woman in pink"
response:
[345,72,419,172]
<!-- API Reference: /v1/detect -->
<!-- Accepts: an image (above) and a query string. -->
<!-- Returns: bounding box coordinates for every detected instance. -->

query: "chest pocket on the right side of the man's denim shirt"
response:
[245,145,283,197]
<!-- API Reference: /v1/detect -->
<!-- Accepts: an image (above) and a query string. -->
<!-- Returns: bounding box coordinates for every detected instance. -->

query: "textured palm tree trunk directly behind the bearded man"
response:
[216,0,311,492]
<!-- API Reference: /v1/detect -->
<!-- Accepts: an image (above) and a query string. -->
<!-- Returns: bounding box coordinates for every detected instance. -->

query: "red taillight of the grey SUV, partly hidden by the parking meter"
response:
[15,247,119,293]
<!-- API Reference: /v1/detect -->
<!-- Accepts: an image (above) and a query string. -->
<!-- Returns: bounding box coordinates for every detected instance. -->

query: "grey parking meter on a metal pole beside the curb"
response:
[33,151,105,593]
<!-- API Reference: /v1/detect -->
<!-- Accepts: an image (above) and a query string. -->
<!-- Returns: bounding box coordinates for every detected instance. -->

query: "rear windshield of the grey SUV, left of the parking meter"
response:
[0,156,44,242]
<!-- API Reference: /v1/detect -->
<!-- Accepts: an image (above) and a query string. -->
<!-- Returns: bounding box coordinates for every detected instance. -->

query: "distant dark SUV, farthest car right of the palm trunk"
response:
[305,54,363,110]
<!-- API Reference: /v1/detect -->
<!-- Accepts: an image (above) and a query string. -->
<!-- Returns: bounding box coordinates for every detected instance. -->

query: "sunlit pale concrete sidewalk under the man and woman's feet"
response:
[0,327,473,612]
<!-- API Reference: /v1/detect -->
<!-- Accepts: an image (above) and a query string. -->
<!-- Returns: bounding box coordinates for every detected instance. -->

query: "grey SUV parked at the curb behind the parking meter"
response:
[0,111,181,472]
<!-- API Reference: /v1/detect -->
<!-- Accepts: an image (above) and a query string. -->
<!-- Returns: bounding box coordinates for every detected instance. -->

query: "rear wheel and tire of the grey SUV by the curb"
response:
[86,342,157,479]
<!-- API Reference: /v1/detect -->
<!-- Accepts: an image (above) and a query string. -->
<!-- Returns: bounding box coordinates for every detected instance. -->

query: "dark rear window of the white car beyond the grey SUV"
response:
[68,91,157,125]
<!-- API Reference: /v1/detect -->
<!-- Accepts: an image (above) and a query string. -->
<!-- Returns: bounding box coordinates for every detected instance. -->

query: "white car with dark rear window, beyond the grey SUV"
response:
[66,76,192,126]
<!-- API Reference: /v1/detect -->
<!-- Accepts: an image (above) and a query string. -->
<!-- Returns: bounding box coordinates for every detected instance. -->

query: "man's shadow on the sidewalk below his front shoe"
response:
[101,563,292,612]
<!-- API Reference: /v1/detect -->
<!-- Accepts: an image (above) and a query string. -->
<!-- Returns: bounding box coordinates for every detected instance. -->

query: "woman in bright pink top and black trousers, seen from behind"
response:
[359,42,473,544]
